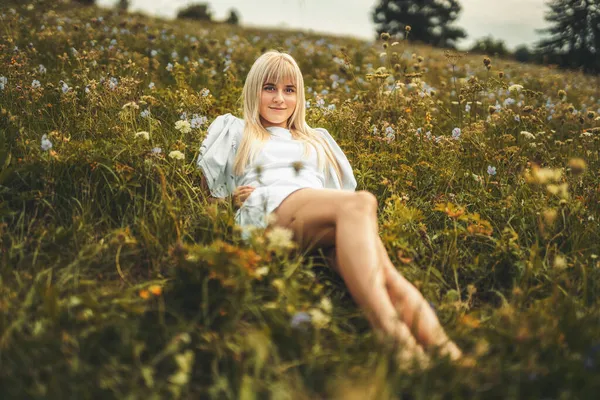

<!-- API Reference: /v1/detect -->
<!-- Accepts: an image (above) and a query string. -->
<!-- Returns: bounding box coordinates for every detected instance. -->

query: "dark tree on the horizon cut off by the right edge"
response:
[536,0,600,72]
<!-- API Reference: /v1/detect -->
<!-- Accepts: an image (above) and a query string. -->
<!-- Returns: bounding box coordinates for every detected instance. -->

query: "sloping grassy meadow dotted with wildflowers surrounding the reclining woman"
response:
[0,0,600,400]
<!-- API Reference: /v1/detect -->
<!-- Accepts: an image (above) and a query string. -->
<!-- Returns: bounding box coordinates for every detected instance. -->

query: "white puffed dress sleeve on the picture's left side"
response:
[197,113,244,198]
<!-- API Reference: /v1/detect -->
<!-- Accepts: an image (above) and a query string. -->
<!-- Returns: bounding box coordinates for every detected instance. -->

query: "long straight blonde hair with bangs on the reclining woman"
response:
[233,50,342,184]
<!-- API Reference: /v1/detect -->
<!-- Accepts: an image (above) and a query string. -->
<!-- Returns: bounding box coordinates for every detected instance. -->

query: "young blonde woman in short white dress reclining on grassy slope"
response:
[198,51,461,362]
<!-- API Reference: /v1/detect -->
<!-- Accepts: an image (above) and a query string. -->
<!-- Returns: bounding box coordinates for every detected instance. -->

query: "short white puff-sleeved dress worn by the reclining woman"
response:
[197,114,356,239]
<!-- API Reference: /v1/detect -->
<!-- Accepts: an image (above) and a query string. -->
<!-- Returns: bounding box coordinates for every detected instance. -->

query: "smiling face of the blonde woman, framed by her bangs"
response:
[260,80,298,128]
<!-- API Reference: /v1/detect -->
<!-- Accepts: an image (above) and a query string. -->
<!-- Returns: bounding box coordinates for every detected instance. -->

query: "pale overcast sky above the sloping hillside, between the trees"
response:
[97,0,547,49]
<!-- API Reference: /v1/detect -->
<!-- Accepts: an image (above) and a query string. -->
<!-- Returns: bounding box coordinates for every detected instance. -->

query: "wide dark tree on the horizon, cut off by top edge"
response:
[372,0,467,48]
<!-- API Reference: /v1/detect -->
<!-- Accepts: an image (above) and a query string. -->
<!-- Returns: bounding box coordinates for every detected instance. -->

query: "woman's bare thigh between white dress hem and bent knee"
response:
[273,188,356,251]
